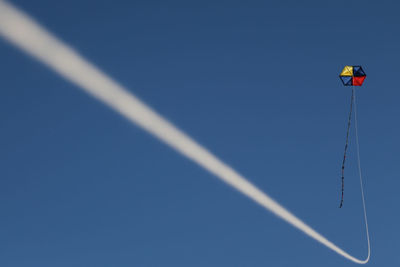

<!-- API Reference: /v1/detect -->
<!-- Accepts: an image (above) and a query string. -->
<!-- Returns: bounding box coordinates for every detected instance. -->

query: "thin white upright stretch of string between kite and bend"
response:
[352,87,371,262]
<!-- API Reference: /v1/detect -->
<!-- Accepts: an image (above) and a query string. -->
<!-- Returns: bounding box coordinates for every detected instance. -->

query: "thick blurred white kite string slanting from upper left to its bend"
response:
[0,0,371,264]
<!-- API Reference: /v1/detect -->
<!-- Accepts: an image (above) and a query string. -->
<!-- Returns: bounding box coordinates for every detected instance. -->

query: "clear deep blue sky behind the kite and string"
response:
[0,0,400,267]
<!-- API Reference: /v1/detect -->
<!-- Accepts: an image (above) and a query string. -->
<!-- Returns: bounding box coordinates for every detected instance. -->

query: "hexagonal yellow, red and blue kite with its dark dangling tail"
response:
[339,66,367,208]
